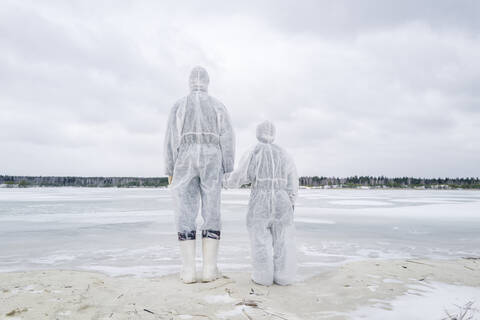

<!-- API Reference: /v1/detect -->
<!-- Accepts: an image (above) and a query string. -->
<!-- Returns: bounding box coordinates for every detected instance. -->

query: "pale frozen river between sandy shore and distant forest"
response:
[0,188,480,277]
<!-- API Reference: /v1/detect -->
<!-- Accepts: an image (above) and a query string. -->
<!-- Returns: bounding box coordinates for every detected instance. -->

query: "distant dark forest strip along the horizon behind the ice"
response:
[0,175,480,189]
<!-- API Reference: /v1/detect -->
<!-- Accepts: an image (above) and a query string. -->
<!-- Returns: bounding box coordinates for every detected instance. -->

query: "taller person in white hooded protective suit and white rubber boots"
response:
[164,67,235,283]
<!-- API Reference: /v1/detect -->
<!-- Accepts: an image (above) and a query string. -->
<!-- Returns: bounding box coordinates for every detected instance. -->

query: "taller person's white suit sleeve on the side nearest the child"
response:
[220,107,235,173]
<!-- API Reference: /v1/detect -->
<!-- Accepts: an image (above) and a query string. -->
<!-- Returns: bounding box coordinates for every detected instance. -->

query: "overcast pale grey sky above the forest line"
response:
[0,0,480,177]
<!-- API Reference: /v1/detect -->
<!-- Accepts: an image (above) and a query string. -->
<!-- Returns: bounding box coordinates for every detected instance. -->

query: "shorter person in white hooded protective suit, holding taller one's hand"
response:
[223,121,298,286]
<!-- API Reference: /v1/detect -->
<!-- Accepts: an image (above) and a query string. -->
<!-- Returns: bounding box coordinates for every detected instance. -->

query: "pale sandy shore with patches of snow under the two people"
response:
[0,259,480,320]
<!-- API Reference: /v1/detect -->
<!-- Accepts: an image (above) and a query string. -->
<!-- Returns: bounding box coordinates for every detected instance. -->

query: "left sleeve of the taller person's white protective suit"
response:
[163,104,180,176]
